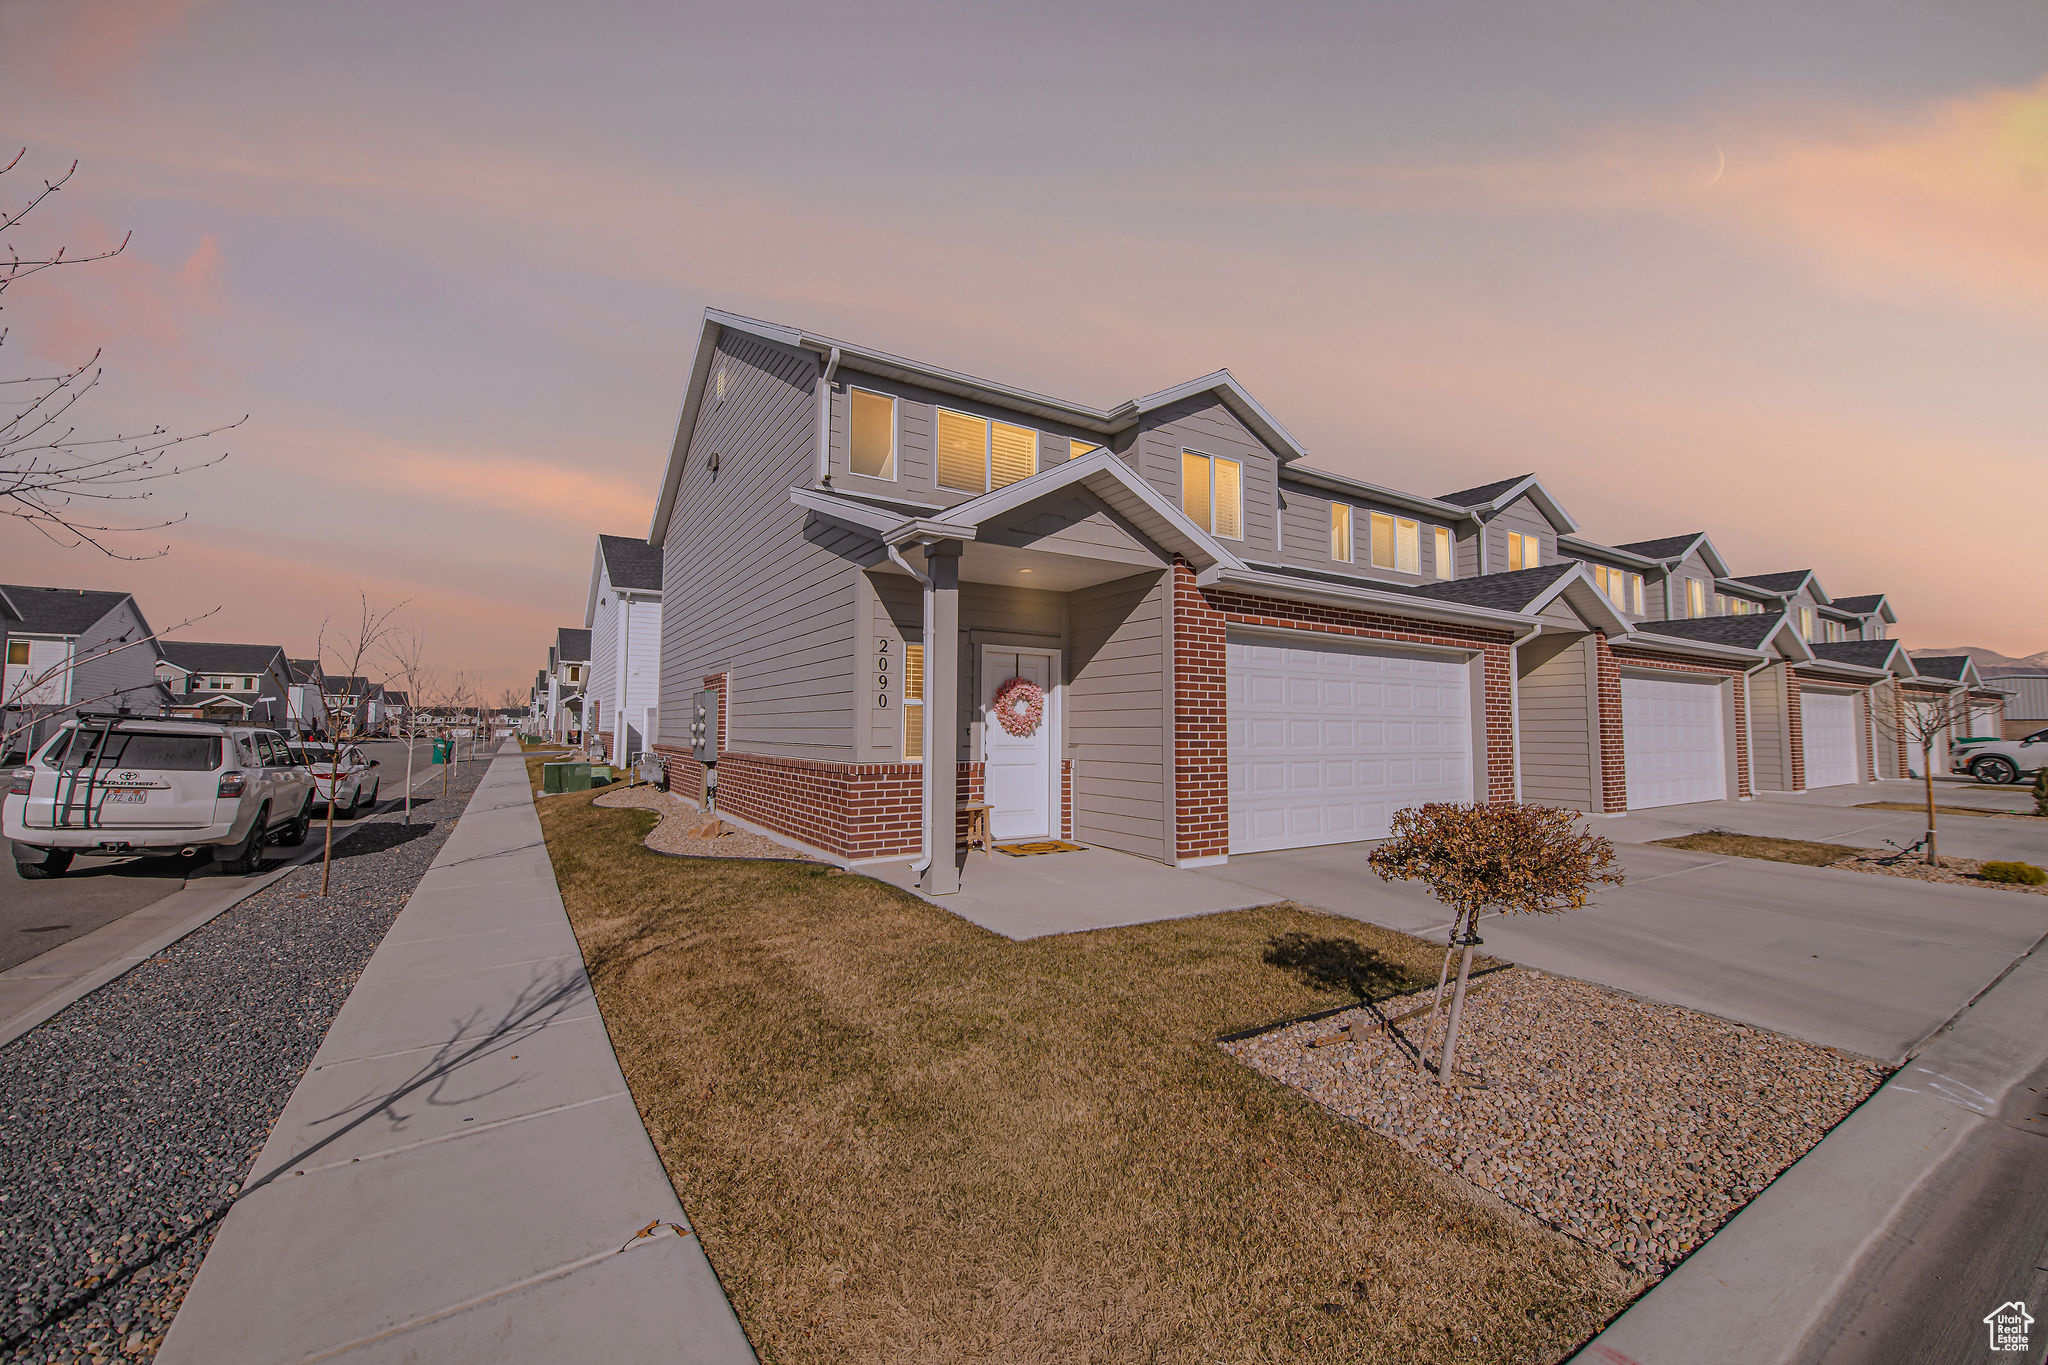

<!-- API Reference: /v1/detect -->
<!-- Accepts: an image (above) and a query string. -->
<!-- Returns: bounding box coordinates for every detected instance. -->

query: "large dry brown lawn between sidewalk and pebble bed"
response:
[541,785,1638,1365]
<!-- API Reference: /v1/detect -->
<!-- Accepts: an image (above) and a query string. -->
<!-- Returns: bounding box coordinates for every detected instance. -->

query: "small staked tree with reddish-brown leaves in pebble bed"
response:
[1366,802,1622,1085]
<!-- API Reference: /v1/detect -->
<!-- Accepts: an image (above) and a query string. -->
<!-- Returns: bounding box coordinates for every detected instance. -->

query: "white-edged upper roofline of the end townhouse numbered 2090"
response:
[647,309,1307,546]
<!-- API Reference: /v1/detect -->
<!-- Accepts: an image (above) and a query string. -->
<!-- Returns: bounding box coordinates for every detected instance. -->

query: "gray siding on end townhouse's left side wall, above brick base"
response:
[659,332,872,761]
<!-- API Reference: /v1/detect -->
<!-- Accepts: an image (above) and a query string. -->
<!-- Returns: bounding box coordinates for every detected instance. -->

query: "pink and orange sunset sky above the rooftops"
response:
[0,0,2048,696]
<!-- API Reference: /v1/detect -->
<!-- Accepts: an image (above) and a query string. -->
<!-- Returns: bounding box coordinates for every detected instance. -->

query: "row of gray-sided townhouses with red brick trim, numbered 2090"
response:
[647,309,1974,890]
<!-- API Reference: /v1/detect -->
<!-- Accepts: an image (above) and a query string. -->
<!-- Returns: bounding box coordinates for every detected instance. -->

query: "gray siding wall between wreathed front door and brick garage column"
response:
[1065,573,1171,860]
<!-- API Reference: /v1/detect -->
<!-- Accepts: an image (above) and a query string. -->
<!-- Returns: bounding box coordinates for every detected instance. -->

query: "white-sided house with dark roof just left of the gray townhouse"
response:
[584,536,662,763]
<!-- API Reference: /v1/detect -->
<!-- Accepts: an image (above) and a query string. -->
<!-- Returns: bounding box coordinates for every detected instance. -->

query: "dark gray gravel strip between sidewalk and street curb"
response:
[0,761,485,1361]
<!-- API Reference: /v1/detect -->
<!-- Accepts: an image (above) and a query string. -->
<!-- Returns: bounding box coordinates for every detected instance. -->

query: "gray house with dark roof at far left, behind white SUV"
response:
[0,583,164,757]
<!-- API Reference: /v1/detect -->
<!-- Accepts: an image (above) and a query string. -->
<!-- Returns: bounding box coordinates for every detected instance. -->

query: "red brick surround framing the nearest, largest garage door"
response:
[1174,561,1516,857]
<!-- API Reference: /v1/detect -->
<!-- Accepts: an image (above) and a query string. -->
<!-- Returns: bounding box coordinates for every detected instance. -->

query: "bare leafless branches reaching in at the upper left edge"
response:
[0,147,248,559]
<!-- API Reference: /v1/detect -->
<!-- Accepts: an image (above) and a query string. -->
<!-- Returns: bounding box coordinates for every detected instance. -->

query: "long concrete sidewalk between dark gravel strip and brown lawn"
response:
[158,749,754,1365]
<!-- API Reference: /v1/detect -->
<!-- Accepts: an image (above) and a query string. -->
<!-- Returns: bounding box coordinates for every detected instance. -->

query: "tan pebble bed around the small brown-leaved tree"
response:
[1223,968,1886,1275]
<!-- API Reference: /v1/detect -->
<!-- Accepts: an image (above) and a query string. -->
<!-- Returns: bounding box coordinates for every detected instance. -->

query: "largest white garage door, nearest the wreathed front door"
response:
[1227,636,1473,853]
